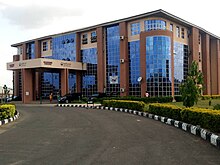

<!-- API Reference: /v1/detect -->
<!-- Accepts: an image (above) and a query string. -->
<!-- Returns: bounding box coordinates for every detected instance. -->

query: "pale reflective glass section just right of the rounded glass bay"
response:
[174,42,188,95]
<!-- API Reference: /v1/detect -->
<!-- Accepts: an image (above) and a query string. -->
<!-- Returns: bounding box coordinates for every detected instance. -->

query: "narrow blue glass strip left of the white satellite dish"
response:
[128,40,141,96]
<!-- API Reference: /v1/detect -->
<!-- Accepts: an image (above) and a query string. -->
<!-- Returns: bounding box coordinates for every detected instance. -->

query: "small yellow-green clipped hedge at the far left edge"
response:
[0,104,16,120]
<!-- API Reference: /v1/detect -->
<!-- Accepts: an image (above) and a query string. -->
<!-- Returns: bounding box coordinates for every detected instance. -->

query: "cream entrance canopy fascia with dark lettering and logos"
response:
[7,58,86,70]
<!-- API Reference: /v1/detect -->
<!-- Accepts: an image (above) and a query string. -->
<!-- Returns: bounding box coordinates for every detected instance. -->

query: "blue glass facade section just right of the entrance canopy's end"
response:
[81,48,98,96]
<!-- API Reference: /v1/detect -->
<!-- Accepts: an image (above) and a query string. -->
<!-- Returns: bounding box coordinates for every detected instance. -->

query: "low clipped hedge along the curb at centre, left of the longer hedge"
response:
[102,100,145,111]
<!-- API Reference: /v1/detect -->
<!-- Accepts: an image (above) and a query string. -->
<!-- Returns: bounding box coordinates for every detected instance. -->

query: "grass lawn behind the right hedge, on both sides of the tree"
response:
[169,99,220,109]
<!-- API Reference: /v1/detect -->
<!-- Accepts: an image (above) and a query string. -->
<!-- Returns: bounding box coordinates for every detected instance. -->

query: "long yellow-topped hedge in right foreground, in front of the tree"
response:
[148,103,220,132]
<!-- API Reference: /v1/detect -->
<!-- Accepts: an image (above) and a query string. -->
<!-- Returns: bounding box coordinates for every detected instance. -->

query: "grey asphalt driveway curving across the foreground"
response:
[0,105,220,165]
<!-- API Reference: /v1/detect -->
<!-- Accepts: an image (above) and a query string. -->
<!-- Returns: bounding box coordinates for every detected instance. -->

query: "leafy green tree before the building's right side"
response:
[180,61,203,107]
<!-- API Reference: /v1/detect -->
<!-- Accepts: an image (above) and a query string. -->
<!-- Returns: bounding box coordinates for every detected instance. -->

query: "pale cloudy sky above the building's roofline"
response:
[0,0,220,87]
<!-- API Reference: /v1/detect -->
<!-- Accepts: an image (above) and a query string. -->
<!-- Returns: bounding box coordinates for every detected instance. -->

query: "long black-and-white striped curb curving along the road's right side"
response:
[57,104,220,149]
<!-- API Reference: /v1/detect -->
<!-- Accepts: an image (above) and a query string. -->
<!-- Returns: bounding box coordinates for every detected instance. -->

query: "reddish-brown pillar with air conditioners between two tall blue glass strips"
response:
[119,22,129,96]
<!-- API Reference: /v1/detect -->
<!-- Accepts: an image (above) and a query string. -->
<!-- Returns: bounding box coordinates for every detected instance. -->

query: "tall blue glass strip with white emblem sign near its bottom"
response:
[106,25,120,96]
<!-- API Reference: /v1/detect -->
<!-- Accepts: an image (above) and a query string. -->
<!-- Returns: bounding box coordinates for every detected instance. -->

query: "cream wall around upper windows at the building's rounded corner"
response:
[127,17,189,45]
